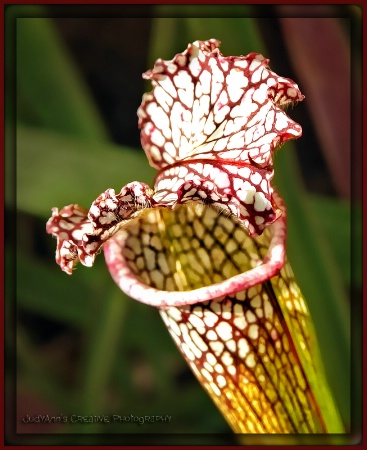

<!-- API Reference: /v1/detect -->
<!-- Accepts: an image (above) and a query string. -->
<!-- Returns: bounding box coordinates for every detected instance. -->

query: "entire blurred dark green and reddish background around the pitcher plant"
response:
[6,6,361,444]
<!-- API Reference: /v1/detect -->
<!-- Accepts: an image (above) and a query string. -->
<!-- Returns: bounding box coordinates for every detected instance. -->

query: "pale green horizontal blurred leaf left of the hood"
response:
[14,125,154,218]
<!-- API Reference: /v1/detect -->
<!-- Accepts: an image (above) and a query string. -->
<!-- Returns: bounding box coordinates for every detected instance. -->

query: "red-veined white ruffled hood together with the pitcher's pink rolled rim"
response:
[46,39,303,300]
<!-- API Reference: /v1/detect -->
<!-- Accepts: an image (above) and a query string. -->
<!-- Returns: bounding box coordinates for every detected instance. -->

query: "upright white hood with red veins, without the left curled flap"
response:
[138,39,303,239]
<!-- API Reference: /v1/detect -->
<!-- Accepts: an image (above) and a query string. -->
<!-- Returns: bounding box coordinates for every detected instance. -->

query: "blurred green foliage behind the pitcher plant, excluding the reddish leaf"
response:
[6,6,361,444]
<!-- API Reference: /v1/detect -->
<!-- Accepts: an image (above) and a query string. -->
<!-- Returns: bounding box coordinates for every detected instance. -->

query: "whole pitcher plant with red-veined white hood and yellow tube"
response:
[46,39,344,433]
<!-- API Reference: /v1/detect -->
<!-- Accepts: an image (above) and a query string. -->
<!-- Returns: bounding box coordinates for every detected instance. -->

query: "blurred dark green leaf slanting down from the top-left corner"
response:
[16,17,107,141]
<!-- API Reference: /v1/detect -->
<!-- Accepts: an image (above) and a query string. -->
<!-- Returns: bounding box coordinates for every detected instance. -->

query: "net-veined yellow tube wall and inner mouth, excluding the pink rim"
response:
[118,205,325,433]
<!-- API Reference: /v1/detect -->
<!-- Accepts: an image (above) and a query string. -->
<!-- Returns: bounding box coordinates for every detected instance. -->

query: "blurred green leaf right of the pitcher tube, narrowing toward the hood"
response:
[274,143,350,424]
